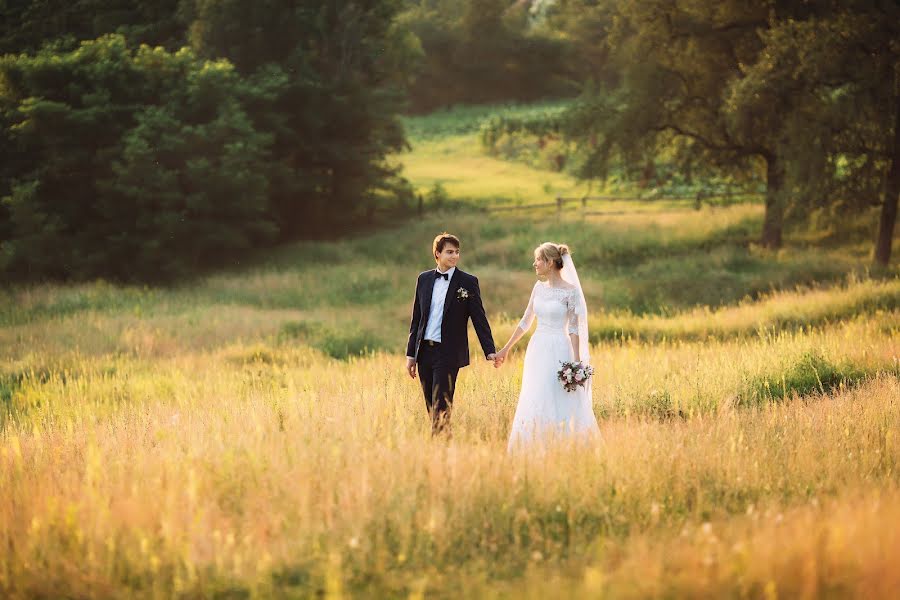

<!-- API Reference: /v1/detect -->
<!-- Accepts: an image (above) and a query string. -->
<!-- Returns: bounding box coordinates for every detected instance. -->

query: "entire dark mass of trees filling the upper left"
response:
[0,0,413,280]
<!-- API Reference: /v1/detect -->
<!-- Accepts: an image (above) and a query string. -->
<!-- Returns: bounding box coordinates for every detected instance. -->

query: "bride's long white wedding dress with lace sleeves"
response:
[508,281,599,450]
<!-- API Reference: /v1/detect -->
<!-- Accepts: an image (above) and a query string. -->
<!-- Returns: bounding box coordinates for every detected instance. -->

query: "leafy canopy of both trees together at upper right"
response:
[555,1,900,255]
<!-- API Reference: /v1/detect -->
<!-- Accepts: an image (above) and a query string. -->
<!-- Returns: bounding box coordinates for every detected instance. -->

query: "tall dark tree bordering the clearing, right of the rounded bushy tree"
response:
[185,0,408,237]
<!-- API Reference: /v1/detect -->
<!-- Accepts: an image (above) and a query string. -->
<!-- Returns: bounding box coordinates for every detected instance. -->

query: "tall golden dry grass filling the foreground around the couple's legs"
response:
[0,324,900,597]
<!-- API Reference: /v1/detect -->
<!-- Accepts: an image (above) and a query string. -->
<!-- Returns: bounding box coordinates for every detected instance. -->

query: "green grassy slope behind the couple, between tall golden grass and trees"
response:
[0,205,898,355]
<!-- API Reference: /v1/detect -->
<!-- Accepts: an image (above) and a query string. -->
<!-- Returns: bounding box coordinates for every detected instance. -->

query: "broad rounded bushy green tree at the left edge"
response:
[0,35,275,280]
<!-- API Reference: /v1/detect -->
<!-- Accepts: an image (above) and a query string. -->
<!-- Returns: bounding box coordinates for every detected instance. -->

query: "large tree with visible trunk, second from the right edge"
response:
[571,0,852,248]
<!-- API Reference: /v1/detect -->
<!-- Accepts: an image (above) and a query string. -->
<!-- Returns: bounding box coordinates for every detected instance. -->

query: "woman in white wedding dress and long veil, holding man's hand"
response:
[495,242,600,451]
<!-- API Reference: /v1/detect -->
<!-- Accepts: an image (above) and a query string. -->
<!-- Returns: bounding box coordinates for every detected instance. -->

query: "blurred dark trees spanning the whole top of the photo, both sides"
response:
[0,0,900,281]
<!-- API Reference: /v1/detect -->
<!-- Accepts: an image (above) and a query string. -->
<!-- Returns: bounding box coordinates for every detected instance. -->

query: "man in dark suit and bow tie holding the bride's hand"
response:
[406,233,497,434]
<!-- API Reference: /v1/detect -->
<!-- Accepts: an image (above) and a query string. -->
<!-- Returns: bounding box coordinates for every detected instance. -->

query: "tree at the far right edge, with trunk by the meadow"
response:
[732,2,900,265]
